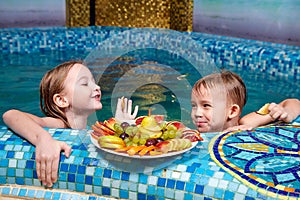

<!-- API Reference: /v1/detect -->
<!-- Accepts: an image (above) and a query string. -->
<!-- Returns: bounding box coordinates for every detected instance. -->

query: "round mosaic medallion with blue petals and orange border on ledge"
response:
[210,119,300,199]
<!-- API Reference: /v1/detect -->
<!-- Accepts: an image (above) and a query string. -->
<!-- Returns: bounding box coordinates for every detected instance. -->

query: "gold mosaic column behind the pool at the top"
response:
[66,0,193,31]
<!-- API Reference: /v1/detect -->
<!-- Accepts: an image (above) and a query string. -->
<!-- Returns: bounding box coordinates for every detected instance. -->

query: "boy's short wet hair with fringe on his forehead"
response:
[192,71,247,110]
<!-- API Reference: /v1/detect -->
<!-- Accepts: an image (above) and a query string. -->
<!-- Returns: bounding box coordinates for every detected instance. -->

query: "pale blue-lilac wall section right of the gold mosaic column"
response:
[193,0,300,46]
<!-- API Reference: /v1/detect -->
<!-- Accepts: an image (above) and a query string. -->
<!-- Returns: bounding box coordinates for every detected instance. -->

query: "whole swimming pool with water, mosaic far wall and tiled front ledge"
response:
[0,27,300,199]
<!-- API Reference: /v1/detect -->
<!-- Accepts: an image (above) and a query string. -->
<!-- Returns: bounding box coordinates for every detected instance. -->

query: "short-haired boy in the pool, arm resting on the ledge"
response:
[191,71,300,132]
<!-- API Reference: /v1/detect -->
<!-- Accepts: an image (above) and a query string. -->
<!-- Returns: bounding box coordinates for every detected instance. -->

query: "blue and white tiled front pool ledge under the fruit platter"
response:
[0,122,299,200]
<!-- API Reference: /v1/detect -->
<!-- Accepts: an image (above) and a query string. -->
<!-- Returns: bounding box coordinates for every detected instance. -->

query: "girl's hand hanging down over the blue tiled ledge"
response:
[35,136,71,187]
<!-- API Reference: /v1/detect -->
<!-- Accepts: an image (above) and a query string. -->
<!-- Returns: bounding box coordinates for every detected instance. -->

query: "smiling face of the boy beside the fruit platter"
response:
[191,85,227,133]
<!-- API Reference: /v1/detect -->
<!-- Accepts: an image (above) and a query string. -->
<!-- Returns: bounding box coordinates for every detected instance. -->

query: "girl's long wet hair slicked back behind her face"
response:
[40,61,83,128]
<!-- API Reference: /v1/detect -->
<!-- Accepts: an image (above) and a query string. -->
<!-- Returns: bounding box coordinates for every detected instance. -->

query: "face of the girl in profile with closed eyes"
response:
[64,64,102,115]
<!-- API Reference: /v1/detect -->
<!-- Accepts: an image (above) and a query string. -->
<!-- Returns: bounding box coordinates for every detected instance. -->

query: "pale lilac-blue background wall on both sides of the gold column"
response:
[0,0,300,46]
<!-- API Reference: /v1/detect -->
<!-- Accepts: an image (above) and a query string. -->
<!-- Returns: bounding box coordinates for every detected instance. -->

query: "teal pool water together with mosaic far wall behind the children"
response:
[0,28,300,126]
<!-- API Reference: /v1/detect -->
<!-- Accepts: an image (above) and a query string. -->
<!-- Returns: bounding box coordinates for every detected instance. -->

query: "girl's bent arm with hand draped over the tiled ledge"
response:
[3,110,71,187]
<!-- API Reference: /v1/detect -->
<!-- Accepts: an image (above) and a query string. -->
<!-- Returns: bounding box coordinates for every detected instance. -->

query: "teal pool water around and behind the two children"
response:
[0,49,300,129]
